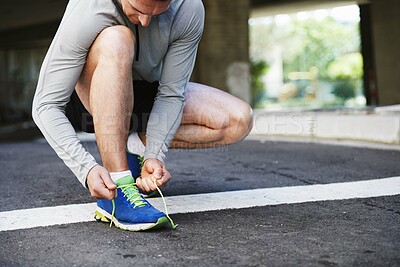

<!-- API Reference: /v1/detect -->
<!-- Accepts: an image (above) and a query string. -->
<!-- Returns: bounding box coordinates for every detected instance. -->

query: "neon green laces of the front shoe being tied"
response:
[110,180,178,229]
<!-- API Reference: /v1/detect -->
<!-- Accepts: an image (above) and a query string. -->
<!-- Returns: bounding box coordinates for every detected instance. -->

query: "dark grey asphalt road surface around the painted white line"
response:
[0,137,400,266]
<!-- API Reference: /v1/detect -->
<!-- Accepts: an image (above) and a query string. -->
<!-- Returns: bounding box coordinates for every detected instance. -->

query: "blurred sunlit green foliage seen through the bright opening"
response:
[250,14,363,107]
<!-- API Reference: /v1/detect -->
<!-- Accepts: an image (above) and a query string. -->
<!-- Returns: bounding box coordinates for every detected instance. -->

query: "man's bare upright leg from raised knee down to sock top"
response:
[76,26,134,172]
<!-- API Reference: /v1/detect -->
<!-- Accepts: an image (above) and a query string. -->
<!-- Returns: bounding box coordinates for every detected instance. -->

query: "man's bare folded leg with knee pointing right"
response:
[140,83,253,148]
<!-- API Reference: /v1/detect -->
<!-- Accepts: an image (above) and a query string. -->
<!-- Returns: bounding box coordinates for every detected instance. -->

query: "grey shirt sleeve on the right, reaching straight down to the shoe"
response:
[144,0,204,162]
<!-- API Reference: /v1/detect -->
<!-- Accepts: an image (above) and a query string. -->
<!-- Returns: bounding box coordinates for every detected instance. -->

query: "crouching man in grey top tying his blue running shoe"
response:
[32,0,252,231]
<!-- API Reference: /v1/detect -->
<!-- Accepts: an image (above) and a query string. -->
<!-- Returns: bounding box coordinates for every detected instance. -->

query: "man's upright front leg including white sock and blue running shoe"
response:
[75,26,175,231]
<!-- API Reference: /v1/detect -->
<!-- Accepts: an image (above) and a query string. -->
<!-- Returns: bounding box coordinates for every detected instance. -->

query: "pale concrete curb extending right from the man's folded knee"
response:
[250,106,400,145]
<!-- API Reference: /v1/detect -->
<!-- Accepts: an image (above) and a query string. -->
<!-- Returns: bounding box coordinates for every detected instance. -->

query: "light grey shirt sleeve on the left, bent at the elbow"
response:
[32,0,116,186]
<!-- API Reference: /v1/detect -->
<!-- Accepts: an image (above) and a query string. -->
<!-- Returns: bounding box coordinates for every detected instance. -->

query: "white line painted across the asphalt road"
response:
[0,177,400,231]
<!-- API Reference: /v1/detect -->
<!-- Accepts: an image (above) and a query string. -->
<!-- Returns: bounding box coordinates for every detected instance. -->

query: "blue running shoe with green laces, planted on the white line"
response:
[95,176,170,231]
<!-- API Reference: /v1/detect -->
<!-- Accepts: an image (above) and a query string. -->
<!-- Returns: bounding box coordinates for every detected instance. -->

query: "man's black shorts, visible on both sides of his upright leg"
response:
[65,81,159,133]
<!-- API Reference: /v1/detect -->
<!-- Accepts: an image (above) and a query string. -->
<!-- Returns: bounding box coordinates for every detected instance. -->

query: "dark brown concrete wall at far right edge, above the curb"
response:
[371,0,400,105]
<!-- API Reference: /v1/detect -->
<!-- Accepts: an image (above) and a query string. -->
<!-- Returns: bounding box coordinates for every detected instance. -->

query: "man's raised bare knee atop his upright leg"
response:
[90,25,135,64]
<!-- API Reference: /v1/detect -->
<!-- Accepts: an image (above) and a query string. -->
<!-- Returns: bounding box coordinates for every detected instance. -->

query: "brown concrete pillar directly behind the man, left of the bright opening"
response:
[193,0,250,102]
